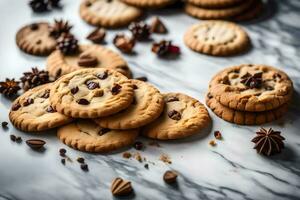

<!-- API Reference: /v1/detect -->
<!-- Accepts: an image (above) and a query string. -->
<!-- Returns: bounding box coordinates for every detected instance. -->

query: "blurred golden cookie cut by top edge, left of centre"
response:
[80,0,142,28]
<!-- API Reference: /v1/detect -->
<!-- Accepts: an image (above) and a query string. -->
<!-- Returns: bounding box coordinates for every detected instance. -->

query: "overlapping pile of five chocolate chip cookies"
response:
[9,68,210,152]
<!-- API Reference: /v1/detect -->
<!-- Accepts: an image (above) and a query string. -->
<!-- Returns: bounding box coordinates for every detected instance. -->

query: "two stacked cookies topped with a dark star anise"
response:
[206,65,293,125]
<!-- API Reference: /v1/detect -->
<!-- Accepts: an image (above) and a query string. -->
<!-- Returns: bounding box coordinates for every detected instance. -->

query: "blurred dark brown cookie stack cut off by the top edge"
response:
[185,0,263,21]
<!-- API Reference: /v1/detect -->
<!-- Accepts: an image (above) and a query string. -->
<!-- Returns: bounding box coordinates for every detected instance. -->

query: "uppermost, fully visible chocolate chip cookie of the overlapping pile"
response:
[50,68,133,118]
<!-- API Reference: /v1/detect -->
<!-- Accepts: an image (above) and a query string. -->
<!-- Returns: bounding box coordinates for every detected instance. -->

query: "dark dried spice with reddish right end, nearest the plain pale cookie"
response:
[152,40,180,56]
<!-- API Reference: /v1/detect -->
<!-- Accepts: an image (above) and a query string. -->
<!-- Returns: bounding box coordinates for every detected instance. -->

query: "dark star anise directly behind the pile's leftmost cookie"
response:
[21,67,50,91]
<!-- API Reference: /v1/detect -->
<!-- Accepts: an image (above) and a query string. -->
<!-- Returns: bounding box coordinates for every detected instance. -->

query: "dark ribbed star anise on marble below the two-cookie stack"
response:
[251,128,285,156]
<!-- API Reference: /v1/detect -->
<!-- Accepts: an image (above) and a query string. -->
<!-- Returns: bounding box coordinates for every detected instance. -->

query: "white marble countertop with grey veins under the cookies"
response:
[0,0,300,200]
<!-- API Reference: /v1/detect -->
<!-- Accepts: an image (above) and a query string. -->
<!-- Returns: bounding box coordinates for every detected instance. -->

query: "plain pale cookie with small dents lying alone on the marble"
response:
[184,20,250,56]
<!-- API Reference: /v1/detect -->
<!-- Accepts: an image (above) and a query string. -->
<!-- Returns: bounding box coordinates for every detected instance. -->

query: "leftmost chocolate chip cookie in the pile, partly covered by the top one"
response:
[9,83,72,132]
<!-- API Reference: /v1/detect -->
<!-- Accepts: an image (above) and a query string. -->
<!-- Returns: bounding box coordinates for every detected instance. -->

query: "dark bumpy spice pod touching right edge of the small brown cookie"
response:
[56,33,78,55]
